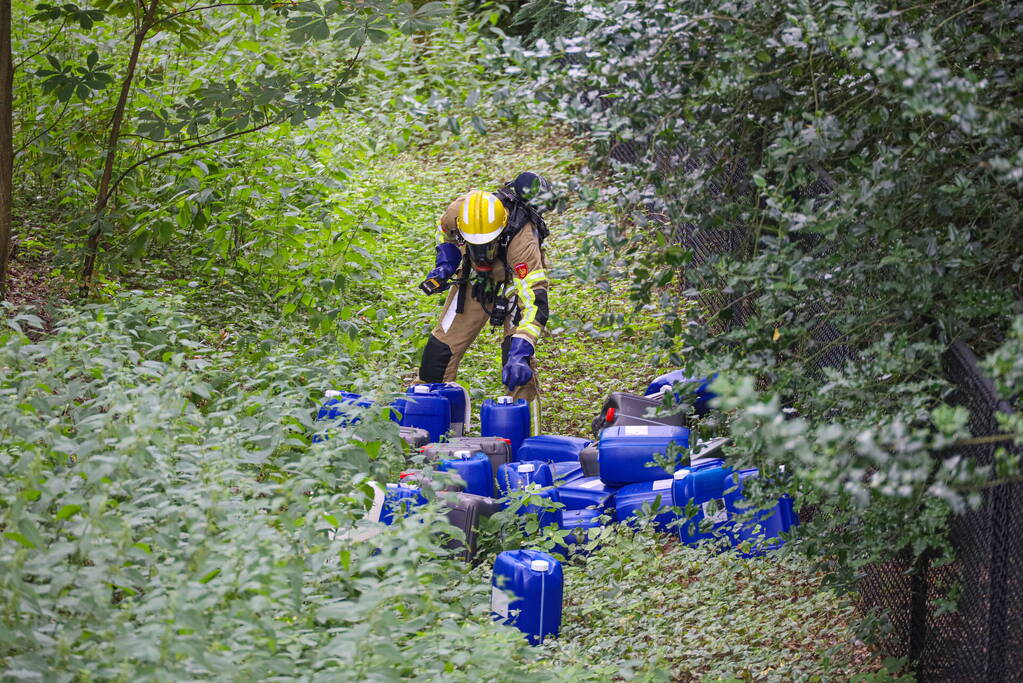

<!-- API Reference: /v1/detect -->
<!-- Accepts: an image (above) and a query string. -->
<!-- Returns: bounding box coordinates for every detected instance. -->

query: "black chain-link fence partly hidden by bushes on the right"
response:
[597,127,1023,682]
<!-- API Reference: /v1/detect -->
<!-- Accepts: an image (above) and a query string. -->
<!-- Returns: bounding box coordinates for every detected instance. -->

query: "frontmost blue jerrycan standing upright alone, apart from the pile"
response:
[490,550,565,645]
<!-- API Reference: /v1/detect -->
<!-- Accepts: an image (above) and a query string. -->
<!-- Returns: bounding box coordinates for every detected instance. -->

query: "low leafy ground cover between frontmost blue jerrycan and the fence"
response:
[543,530,904,681]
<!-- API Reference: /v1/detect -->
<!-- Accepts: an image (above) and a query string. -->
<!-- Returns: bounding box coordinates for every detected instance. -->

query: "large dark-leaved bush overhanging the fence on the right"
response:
[504,0,1023,579]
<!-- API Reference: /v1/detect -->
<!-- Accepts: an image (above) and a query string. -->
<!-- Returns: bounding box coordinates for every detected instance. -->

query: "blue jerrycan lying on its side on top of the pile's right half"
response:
[597,425,690,488]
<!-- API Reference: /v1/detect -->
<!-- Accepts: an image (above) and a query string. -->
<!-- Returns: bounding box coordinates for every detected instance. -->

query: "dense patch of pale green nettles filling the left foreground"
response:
[0,293,552,681]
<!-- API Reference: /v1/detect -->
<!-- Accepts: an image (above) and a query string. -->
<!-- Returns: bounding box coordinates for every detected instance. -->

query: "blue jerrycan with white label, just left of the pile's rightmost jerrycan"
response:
[671,461,737,545]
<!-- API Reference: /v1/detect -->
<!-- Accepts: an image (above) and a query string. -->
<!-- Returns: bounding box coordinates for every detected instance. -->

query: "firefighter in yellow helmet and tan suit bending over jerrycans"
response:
[419,173,550,435]
